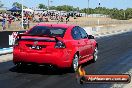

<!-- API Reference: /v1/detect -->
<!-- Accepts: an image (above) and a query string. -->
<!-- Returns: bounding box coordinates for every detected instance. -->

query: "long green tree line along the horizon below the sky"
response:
[38,4,132,20]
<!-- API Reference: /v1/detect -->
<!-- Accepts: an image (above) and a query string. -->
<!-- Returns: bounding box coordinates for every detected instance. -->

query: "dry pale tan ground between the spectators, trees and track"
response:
[0,17,132,32]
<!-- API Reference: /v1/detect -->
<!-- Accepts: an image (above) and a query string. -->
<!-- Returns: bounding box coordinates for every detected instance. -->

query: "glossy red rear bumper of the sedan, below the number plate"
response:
[13,51,72,68]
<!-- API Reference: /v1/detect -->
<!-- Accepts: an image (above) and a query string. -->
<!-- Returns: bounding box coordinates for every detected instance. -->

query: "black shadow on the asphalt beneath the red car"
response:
[9,61,93,75]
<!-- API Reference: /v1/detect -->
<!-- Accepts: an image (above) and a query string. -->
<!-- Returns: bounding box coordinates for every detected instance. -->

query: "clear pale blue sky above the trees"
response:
[1,0,132,9]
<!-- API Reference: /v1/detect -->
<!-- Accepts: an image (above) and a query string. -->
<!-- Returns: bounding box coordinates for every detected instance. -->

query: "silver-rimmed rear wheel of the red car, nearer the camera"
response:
[71,54,79,72]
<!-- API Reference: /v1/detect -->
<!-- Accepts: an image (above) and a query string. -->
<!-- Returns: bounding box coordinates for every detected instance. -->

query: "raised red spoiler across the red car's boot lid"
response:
[16,34,62,42]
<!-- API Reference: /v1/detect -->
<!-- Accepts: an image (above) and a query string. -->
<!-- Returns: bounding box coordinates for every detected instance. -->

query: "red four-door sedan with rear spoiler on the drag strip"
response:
[13,24,98,72]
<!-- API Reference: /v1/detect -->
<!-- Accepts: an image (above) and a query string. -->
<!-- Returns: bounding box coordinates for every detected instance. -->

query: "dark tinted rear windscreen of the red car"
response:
[28,26,66,37]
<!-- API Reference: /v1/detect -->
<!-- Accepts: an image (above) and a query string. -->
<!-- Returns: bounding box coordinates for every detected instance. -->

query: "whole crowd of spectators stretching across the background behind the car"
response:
[0,12,73,30]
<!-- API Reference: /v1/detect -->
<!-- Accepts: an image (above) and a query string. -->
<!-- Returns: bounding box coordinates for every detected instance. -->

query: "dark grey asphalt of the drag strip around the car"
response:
[0,32,132,88]
